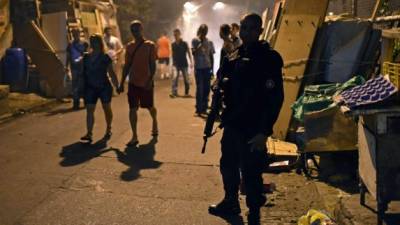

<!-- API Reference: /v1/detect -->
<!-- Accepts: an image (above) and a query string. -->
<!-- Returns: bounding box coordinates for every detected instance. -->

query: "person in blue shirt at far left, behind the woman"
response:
[65,29,89,110]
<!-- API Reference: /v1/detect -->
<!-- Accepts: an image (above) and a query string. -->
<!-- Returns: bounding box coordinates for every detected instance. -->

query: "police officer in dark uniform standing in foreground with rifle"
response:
[209,14,284,224]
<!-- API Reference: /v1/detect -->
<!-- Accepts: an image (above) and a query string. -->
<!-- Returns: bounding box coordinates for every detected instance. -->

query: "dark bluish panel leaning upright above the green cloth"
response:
[305,19,381,84]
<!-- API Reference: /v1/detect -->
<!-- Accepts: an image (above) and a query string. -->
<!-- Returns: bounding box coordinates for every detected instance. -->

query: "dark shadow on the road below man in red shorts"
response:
[114,137,162,181]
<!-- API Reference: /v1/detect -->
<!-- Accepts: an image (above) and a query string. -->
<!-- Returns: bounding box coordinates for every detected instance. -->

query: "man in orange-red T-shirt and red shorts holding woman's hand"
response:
[118,20,158,147]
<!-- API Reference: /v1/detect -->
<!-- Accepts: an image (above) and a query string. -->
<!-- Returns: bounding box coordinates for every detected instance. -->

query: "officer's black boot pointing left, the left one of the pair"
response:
[208,196,240,216]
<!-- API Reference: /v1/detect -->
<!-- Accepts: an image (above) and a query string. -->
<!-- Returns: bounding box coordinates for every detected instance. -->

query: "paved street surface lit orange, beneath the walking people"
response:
[0,81,323,225]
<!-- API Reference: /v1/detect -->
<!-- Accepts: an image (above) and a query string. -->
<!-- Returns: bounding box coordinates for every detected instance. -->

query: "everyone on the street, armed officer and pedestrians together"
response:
[66,14,283,224]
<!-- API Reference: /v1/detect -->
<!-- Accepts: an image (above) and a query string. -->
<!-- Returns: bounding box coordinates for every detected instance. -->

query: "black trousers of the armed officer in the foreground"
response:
[220,127,267,209]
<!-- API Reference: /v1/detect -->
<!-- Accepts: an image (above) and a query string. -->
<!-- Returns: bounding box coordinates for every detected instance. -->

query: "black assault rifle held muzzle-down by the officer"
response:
[201,79,223,154]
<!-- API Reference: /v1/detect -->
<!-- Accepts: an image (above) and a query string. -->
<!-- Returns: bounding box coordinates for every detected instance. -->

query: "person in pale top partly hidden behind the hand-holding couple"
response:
[104,27,124,82]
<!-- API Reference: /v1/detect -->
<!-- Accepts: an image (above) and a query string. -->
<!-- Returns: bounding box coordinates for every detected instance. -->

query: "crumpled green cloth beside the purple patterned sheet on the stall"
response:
[292,76,365,122]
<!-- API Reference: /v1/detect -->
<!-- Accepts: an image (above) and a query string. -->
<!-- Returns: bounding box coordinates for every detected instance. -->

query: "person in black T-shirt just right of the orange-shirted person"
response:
[170,29,193,98]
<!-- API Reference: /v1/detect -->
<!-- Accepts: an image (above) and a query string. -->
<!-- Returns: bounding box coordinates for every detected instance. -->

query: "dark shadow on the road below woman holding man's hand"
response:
[60,139,112,167]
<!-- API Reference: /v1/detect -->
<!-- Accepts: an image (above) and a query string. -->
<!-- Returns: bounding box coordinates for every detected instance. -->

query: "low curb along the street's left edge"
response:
[0,99,63,124]
